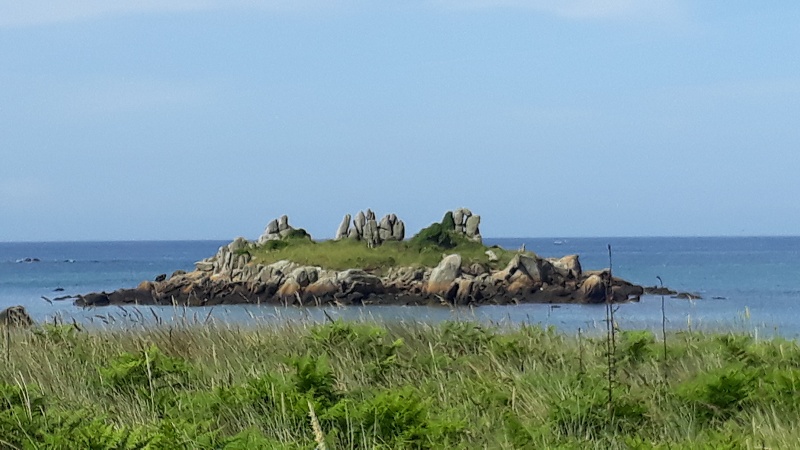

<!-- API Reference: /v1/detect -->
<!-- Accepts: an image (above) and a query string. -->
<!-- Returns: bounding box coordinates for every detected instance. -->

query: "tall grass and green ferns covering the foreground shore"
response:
[0,322,800,449]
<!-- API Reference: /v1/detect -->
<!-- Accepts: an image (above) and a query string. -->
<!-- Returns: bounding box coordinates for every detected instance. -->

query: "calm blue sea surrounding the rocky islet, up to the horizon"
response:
[0,237,800,339]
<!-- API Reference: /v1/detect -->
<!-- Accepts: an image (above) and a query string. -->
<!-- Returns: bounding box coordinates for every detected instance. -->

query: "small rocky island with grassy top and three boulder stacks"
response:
[75,208,644,306]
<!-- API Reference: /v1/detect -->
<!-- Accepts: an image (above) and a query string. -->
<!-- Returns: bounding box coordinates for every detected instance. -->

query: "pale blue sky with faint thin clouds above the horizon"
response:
[0,0,800,241]
